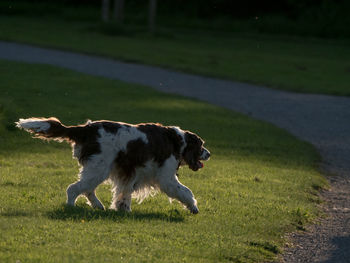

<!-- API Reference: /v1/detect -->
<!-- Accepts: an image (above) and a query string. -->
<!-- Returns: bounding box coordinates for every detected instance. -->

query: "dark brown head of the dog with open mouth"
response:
[182,131,210,171]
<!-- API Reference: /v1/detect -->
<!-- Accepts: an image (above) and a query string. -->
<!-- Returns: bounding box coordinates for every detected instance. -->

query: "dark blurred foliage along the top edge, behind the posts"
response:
[0,0,350,38]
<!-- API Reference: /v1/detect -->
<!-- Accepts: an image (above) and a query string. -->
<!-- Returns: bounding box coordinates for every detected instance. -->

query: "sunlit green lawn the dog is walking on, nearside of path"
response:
[0,61,326,262]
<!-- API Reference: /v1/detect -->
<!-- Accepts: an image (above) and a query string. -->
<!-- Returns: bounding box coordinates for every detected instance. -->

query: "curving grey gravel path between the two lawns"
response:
[0,41,350,263]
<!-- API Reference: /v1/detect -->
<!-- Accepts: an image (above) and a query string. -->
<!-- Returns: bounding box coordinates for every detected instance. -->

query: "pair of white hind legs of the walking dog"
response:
[67,157,110,209]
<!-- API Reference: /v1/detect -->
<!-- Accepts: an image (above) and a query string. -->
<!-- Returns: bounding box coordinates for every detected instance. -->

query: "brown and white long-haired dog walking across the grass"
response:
[16,118,210,214]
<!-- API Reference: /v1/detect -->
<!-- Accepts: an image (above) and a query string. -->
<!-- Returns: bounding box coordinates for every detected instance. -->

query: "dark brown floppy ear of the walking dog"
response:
[183,131,203,171]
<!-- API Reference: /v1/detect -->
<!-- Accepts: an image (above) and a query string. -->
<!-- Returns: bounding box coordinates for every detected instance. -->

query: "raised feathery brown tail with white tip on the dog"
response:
[16,117,71,142]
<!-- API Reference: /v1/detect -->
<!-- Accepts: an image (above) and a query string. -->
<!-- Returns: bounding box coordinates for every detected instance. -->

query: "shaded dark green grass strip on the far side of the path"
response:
[0,1,350,96]
